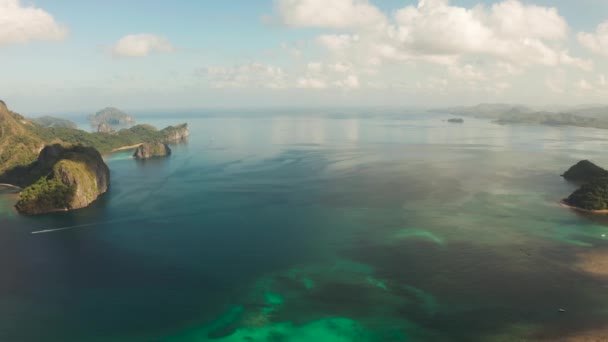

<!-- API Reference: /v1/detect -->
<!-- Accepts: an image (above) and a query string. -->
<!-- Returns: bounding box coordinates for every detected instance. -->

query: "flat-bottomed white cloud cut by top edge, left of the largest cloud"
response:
[276,0,386,29]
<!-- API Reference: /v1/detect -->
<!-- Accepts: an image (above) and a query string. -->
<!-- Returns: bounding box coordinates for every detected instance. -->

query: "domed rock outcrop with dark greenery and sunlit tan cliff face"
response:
[15,144,110,215]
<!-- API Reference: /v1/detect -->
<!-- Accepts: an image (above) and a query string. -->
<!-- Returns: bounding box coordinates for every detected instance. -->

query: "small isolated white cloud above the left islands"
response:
[112,33,175,57]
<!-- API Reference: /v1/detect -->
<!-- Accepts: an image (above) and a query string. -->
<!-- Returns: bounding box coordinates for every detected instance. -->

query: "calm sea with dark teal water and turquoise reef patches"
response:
[0,111,608,342]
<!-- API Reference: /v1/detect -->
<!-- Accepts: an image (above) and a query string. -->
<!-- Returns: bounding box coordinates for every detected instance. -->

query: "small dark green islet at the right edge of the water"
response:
[562,160,608,212]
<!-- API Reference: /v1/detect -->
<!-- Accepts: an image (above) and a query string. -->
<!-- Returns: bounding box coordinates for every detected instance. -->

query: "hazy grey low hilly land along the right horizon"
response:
[431,103,608,129]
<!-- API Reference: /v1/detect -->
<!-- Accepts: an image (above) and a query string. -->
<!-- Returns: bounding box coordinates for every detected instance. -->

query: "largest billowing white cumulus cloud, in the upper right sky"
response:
[389,0,587,68]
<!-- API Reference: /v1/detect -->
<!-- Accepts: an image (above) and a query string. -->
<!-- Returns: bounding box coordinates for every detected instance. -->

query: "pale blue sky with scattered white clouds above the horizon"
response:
[0,0,608,114]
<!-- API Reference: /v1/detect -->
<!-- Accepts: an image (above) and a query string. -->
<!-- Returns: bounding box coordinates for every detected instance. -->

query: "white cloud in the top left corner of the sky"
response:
[0,0,68,46]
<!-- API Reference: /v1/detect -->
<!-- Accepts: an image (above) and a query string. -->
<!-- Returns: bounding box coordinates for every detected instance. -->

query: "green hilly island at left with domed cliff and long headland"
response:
[0,101,189,215]
